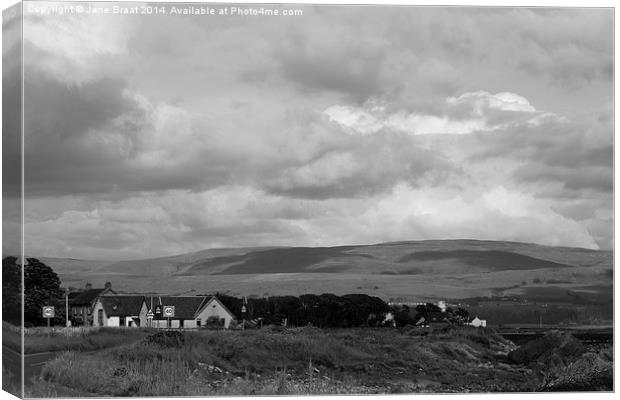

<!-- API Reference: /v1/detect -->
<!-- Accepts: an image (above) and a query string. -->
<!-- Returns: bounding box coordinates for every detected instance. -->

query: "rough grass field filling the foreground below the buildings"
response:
[21,326,611,397]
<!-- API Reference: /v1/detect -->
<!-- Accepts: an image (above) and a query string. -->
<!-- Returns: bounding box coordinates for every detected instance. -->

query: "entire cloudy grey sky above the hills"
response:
[3,5,613,260]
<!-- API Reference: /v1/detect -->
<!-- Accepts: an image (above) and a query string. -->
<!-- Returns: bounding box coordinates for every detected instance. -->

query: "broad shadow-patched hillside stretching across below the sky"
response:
[39,240,613,299]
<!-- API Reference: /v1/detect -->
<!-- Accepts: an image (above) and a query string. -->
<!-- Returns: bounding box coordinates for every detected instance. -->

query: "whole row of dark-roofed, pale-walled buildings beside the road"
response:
[69,283,235,328]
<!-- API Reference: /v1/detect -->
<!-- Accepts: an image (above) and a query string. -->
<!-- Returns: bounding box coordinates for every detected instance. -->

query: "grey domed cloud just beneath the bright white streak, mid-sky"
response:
[262,133,458,199]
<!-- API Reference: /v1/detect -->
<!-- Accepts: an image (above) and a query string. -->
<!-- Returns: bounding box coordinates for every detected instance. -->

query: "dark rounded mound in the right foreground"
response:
[508,331,586,364]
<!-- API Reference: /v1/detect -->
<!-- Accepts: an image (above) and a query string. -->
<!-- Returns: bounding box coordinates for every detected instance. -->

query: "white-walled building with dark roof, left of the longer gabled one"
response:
[93,296,148,327]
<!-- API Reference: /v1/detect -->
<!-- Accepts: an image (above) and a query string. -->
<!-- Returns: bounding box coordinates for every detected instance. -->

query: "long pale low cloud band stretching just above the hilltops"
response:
[25,184,603,259]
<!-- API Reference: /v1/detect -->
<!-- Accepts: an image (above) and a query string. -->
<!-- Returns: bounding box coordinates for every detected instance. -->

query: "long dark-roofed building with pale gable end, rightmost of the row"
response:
[146,296,235,328]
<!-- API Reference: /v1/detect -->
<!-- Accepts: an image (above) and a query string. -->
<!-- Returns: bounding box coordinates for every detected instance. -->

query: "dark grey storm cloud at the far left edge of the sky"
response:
[24,70,135,195]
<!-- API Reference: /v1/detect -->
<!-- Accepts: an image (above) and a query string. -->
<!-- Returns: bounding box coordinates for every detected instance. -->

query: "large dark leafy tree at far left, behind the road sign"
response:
[24,258,64,325]
